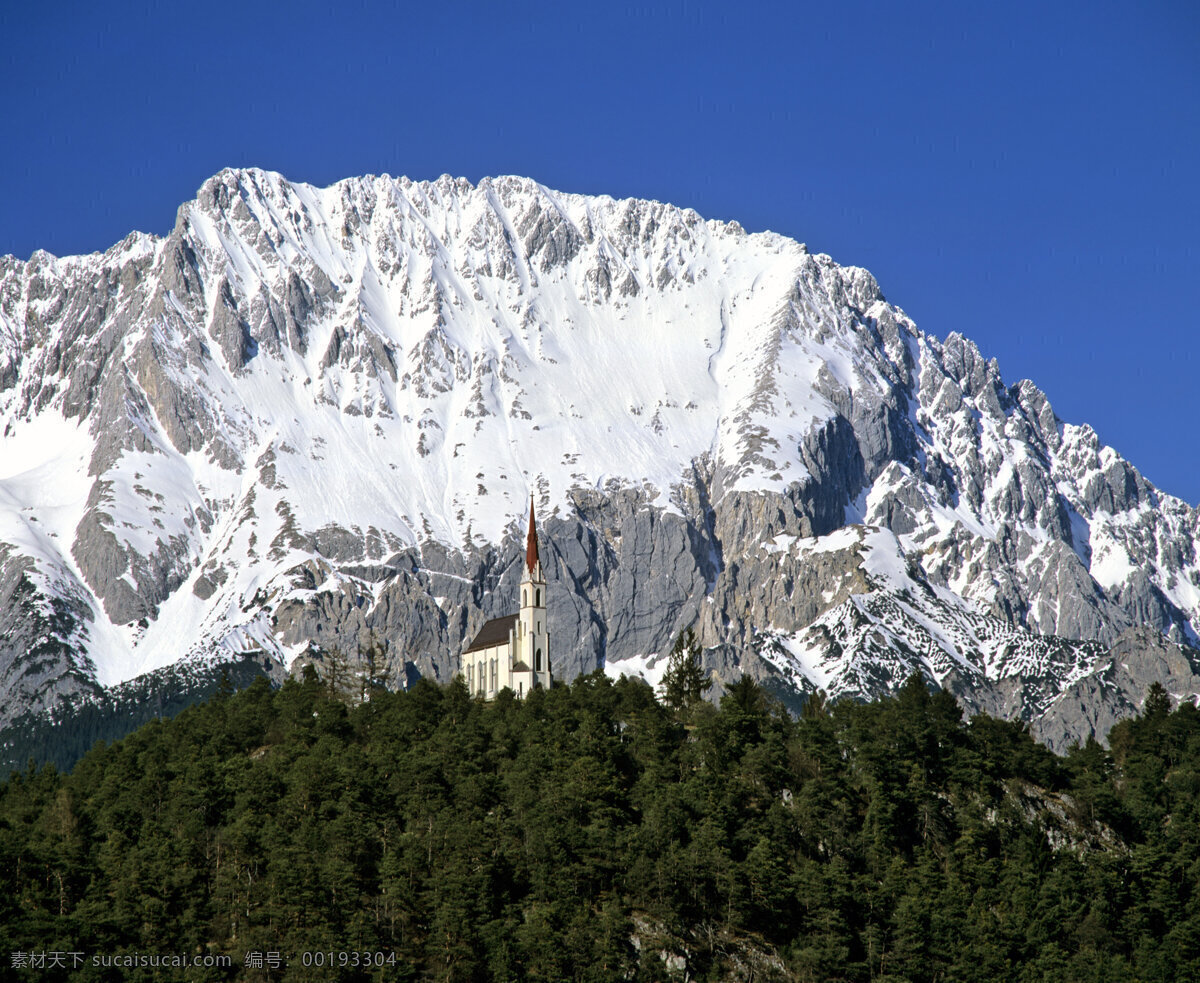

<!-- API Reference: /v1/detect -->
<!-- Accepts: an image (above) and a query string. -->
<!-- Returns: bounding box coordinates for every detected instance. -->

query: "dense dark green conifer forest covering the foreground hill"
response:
[0,675,1200,981]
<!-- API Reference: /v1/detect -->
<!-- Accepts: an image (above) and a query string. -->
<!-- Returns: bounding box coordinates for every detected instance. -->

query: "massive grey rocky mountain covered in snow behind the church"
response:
[0,170,1200,741]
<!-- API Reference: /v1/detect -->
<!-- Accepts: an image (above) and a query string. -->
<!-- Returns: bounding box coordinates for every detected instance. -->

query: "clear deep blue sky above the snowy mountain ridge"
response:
[7,0,1200,504]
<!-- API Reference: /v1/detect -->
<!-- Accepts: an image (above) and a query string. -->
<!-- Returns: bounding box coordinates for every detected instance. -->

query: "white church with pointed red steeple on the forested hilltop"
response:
[462,502,550,700]
